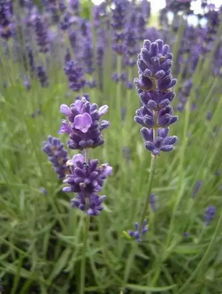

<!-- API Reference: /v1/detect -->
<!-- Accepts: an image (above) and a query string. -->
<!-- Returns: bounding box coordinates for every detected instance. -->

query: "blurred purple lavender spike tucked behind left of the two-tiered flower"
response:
[42,136,68,179]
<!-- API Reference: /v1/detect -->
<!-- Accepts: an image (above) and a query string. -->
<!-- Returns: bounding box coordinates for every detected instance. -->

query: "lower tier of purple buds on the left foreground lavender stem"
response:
[63,154,112,215]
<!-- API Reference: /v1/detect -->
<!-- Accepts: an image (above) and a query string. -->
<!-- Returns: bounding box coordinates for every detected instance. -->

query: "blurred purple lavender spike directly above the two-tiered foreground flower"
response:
[64,60,86,91]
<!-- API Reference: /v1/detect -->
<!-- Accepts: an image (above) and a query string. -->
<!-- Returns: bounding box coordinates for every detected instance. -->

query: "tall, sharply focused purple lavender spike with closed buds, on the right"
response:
[135,40,177,155]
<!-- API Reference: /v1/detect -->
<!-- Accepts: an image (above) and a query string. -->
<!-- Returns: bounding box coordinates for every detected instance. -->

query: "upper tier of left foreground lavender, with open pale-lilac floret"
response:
[59,96,109,150]
